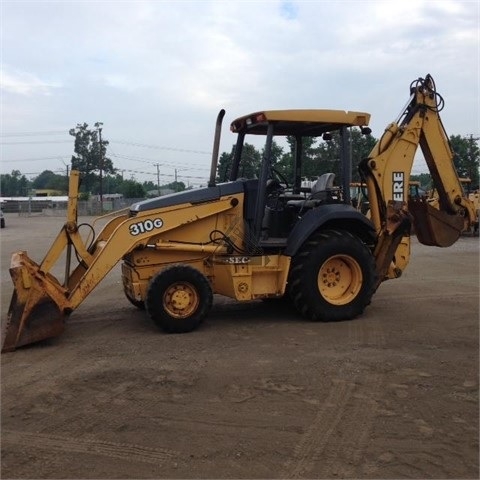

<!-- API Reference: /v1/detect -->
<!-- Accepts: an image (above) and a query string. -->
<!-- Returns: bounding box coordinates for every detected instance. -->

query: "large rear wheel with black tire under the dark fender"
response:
[288,230,377,322]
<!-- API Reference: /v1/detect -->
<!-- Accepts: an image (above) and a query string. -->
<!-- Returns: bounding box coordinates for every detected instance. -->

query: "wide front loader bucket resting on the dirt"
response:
[2,252,66,353]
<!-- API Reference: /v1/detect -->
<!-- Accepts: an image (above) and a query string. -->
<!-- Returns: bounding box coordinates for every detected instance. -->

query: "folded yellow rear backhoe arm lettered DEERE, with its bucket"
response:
[360,75,475,282]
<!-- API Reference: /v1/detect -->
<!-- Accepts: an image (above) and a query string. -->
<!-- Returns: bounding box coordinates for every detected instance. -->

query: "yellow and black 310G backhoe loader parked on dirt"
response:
[2,75,475,352]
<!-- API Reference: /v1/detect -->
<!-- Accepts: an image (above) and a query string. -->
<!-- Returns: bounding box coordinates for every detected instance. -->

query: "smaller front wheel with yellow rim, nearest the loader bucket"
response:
[146,265,213,333]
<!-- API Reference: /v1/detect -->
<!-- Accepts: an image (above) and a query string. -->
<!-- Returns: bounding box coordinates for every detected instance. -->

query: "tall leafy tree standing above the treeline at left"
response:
[69,122,115,193]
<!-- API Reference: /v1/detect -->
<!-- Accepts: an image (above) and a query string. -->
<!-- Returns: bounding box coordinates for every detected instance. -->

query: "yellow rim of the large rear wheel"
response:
[318,255,363,305]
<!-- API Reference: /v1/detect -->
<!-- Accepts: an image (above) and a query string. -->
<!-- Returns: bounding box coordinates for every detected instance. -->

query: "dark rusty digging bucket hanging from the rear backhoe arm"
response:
[408,198,464,247]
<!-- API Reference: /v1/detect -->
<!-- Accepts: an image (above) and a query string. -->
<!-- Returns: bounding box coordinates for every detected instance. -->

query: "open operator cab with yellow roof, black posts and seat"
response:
[224,110,371,248]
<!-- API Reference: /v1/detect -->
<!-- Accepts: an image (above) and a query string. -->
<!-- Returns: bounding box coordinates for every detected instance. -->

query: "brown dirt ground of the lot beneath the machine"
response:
[0,215,479,479]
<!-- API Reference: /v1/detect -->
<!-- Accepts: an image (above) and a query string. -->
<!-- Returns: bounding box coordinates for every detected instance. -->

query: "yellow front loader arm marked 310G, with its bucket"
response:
[2,171,238,352]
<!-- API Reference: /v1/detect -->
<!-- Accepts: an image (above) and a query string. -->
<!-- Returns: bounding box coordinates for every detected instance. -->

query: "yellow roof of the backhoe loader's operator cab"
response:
[230,110,370,137]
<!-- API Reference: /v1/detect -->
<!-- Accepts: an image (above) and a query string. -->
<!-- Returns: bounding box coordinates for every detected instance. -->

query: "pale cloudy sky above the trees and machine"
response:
[0,0,480,186]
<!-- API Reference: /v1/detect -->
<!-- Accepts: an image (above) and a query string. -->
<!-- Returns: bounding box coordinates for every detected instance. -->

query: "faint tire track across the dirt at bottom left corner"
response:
[2,430,180,465]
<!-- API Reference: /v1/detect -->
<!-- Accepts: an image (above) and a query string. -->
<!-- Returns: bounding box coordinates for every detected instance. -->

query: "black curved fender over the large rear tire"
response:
[285,203,376,257]
